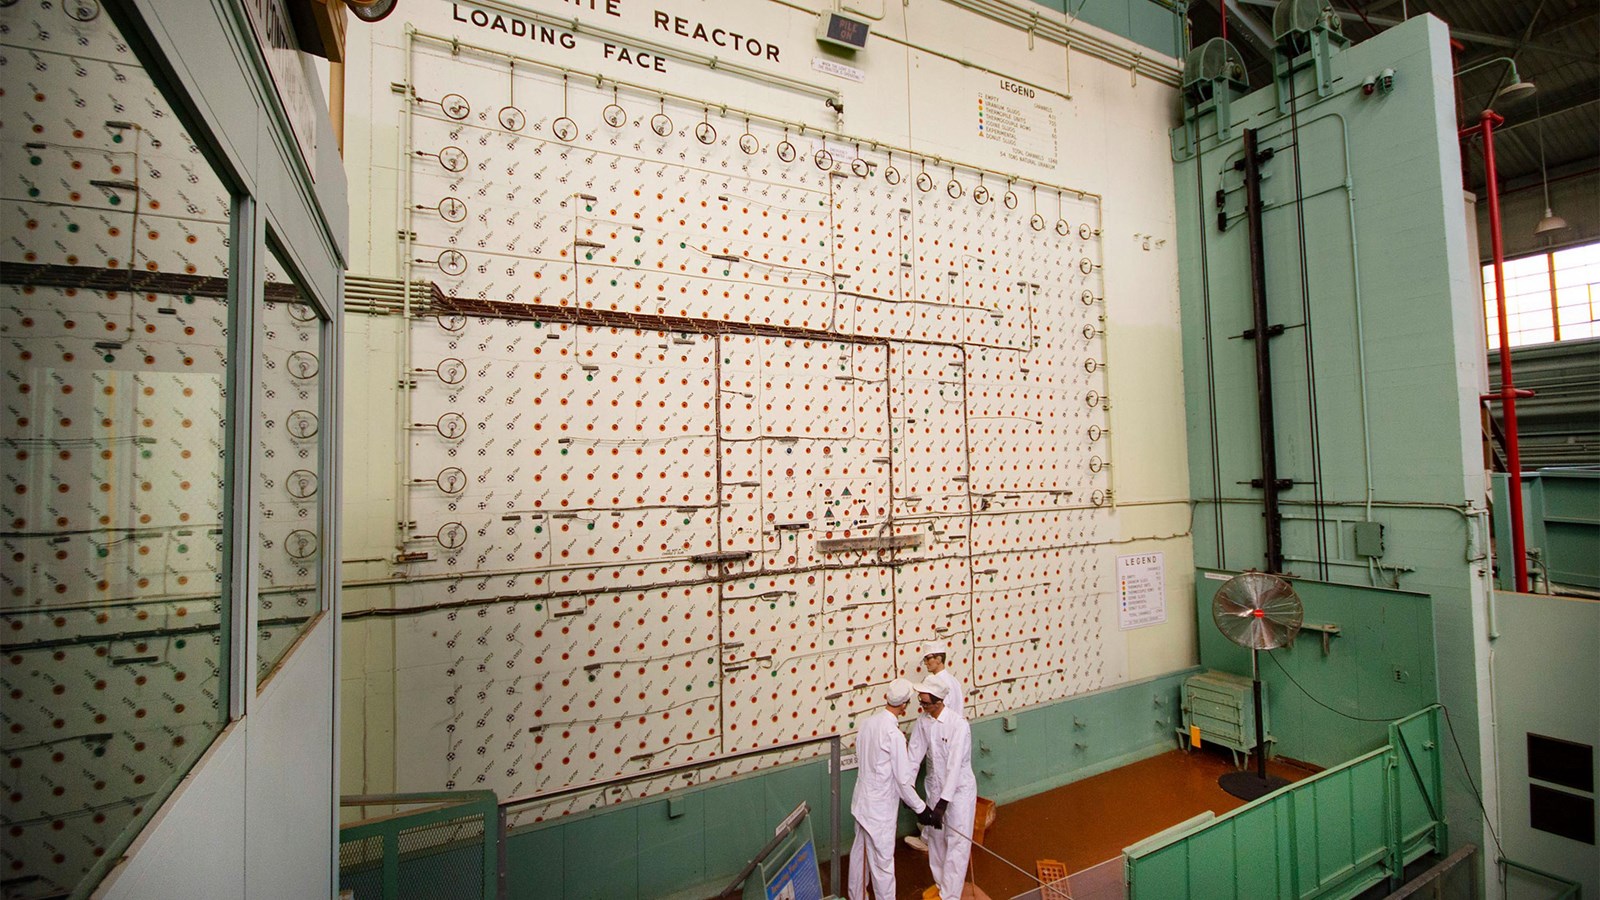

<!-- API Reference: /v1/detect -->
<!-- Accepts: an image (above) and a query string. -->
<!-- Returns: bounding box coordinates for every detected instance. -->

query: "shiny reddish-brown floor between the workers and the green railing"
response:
[870,748,1310,900]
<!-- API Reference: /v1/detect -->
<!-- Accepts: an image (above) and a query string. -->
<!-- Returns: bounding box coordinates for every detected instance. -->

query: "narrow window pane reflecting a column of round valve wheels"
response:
[256,243,325,682]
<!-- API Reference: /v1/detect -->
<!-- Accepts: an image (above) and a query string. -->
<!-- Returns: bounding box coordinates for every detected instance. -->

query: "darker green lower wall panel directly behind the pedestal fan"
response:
[1195,569,1437,767]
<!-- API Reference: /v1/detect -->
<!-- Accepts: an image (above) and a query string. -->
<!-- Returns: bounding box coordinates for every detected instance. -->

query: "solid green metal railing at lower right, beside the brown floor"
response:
[1123,706,1445,900]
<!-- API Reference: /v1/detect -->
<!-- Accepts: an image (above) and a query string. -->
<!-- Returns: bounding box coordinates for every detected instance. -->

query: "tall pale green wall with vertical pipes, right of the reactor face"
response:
[1174,16,1491,864]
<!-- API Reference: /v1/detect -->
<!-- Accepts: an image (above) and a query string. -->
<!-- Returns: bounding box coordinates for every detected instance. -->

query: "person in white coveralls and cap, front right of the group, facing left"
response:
[907,679,978,900]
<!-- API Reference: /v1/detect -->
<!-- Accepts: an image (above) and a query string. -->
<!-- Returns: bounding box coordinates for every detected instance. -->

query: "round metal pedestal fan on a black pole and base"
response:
[1211,572,1306,801]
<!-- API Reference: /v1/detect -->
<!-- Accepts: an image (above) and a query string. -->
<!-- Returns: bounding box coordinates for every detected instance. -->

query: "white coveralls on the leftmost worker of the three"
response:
[846,709,926,900]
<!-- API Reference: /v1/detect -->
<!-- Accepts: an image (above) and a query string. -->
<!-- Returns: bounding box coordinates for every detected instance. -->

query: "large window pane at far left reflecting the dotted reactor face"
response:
[0,0,230,900]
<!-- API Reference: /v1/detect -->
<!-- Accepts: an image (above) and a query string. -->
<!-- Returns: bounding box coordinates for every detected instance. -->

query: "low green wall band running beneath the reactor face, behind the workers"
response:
[506,669,1198,900]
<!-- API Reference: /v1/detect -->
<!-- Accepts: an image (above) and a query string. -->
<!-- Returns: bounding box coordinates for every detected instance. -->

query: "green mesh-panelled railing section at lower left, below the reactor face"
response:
[339,791,504,900]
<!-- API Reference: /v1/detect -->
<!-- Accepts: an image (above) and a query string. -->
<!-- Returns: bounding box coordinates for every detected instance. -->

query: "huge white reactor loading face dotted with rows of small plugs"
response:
[353,0,1120,817]
